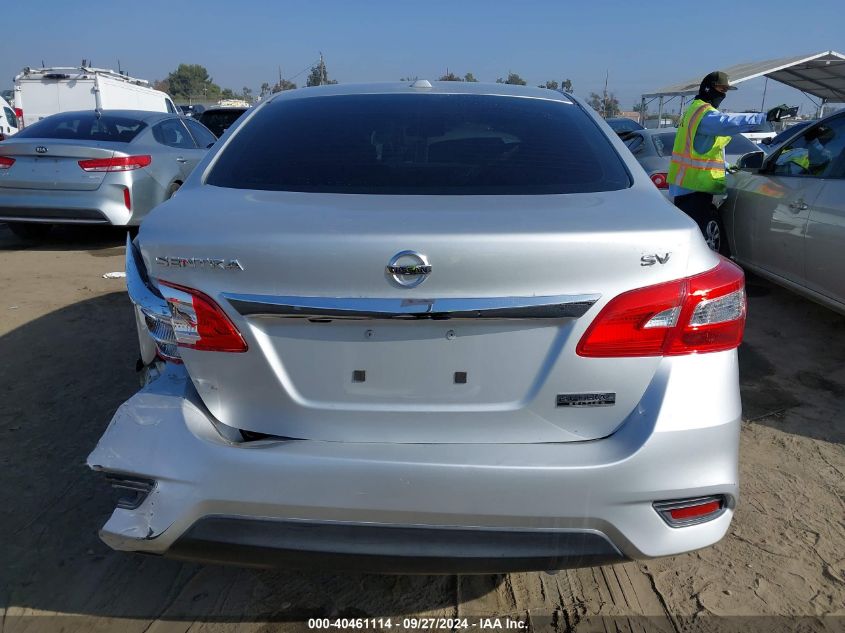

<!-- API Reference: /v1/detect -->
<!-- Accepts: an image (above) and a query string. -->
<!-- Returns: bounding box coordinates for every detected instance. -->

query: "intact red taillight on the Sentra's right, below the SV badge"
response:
[576,258,746,358]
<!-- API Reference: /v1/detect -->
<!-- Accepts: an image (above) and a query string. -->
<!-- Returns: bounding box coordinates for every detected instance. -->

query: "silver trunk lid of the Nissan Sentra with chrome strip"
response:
[139,186,712,443]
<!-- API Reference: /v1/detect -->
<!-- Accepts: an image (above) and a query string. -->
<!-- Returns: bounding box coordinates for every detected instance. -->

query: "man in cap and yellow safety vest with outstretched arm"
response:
[667,71,788,251]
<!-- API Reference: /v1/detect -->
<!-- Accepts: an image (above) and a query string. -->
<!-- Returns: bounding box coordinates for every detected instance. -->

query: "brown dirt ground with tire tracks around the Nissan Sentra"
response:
[0,225,845,633]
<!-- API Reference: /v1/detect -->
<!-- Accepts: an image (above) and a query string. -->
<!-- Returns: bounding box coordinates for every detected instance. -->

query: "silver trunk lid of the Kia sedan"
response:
[0,138,125,191]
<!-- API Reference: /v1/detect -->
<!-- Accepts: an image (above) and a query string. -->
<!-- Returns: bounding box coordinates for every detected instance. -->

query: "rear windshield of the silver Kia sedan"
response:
[17,112,147,143]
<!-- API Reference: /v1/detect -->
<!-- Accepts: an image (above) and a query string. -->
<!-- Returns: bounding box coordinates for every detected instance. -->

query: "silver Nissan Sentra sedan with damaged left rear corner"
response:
[88,81,745,573]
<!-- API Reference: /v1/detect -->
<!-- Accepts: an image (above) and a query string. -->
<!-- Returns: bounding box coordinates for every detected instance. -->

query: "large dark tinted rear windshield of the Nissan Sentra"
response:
[203,94,631,195]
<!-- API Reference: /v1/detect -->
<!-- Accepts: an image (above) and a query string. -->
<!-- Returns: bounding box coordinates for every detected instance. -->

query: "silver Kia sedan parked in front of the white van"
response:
[0,110,215,239]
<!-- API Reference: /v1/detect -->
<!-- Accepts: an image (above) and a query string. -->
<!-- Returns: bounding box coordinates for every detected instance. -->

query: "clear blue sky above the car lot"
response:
[0,0,845,114]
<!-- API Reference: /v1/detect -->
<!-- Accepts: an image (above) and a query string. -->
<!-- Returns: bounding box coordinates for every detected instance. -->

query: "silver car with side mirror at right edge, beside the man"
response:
[722,112,845,314]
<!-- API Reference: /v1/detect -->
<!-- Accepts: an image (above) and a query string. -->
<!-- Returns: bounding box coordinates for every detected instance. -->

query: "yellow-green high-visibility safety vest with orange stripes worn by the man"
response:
[667,99,731,193]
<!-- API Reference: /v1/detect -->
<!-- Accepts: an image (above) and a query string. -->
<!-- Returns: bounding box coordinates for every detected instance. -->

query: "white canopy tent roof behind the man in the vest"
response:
[640,51,845,123]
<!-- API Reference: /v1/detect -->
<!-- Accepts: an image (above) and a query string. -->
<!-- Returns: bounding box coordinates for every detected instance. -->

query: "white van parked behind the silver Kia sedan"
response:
[15,66,179,127]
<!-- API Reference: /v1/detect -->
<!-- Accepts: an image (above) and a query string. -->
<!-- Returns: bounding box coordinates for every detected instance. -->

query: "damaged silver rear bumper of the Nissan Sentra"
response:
[88,365,739,573]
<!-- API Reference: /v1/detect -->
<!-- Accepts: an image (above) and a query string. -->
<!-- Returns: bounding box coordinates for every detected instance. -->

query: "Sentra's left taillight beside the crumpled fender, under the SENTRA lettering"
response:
[160,281,247,352]
